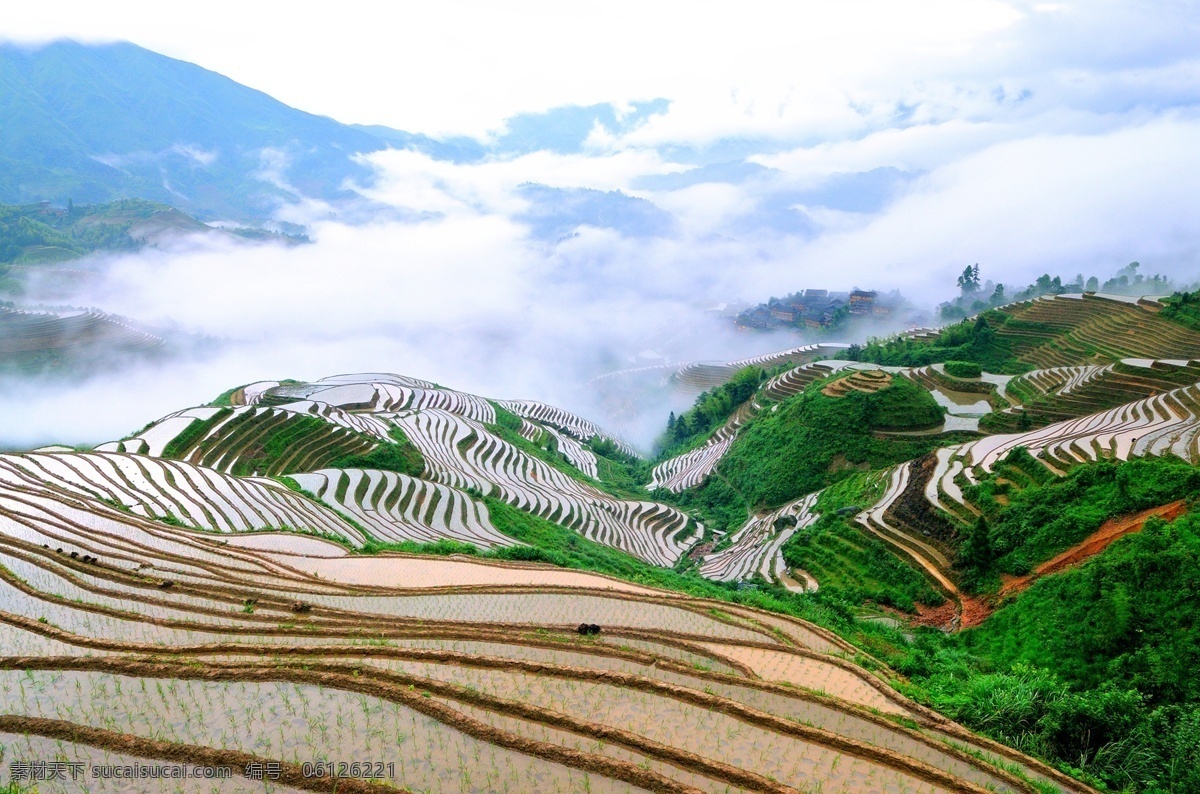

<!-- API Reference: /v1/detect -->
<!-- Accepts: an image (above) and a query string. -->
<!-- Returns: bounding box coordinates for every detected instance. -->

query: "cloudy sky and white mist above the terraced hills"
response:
[0,0,1200,448]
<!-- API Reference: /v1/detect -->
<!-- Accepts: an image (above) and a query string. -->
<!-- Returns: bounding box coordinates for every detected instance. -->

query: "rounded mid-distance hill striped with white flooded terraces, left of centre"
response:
[108,373,702,565]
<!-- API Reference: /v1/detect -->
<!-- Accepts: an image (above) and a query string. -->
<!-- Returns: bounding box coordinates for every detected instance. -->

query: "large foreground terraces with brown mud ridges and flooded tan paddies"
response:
[0,472,1087,794]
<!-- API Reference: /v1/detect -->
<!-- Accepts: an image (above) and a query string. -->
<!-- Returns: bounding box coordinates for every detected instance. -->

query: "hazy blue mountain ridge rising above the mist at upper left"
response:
[0,41,405,218]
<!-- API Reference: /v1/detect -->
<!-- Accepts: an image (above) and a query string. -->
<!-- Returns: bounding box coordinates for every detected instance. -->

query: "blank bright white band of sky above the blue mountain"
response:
[0,0,1020,138]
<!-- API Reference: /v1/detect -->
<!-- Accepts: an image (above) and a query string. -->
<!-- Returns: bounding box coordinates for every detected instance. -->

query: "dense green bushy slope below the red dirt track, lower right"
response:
[896,504,1200,792]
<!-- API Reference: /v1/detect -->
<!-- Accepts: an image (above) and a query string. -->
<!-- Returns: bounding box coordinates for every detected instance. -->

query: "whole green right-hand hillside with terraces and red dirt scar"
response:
[655,293,1200,792]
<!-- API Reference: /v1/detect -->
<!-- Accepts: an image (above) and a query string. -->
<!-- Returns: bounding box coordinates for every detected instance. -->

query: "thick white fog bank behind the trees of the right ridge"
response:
[777,119,1200,293]
